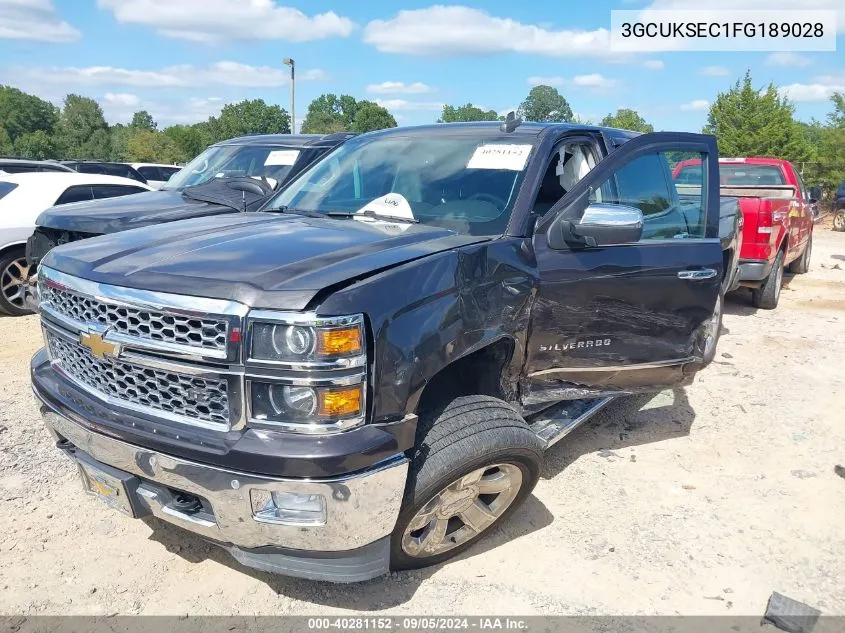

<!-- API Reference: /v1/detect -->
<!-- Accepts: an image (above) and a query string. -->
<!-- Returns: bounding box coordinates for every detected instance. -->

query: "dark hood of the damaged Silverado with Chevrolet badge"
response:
[42,213,488,310]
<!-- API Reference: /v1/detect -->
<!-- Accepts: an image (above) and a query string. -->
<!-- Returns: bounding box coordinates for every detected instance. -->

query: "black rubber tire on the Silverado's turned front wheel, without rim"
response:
[390,396,544,570]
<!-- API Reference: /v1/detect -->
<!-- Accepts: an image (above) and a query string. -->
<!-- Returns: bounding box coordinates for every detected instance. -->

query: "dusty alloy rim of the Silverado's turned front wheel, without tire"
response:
[402,464,522,558]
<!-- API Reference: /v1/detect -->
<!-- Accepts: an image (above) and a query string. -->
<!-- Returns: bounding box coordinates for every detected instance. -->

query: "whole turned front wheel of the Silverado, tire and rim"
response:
[391,396,543,570]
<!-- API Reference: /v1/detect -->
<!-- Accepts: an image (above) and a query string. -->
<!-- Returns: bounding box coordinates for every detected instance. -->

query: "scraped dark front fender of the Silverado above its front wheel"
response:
[318,238,537,422]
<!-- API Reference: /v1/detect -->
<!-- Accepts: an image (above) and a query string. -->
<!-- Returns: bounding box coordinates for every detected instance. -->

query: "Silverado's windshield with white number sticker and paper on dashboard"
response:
[264,135,533,235]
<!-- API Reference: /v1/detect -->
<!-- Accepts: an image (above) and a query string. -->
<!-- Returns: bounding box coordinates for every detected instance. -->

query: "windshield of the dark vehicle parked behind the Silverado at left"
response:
[164,145,300,190]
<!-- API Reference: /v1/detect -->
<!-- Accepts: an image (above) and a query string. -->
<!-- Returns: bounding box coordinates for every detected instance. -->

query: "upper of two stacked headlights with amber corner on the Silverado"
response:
[250,312,364,367]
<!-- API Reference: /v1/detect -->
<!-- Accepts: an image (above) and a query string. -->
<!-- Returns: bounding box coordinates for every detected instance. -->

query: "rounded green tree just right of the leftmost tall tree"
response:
[56,94,111,159]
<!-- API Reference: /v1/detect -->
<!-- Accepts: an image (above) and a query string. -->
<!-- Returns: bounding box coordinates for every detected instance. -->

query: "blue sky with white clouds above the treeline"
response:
[0,0,845,131]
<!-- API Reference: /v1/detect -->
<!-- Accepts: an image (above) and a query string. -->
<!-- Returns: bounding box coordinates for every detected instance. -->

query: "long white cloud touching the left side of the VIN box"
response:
[364,5,614,57]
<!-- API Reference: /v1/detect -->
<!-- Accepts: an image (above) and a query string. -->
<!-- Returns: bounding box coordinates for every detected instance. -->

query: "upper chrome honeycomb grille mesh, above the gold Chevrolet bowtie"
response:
[39,284,228,352]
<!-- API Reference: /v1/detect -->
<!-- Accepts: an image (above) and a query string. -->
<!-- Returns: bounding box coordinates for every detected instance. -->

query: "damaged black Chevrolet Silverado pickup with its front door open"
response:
[31,120,735,582]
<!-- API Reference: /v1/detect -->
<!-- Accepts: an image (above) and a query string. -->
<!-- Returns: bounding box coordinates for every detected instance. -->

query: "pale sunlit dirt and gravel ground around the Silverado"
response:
[0,229,845,615]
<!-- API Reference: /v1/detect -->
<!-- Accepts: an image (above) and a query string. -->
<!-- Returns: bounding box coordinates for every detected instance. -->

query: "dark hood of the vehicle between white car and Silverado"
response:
[35,190,236,235]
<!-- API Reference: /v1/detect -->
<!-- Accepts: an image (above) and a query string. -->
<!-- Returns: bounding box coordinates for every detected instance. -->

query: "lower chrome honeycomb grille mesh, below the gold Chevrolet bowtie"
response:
[45,329,230,429]
